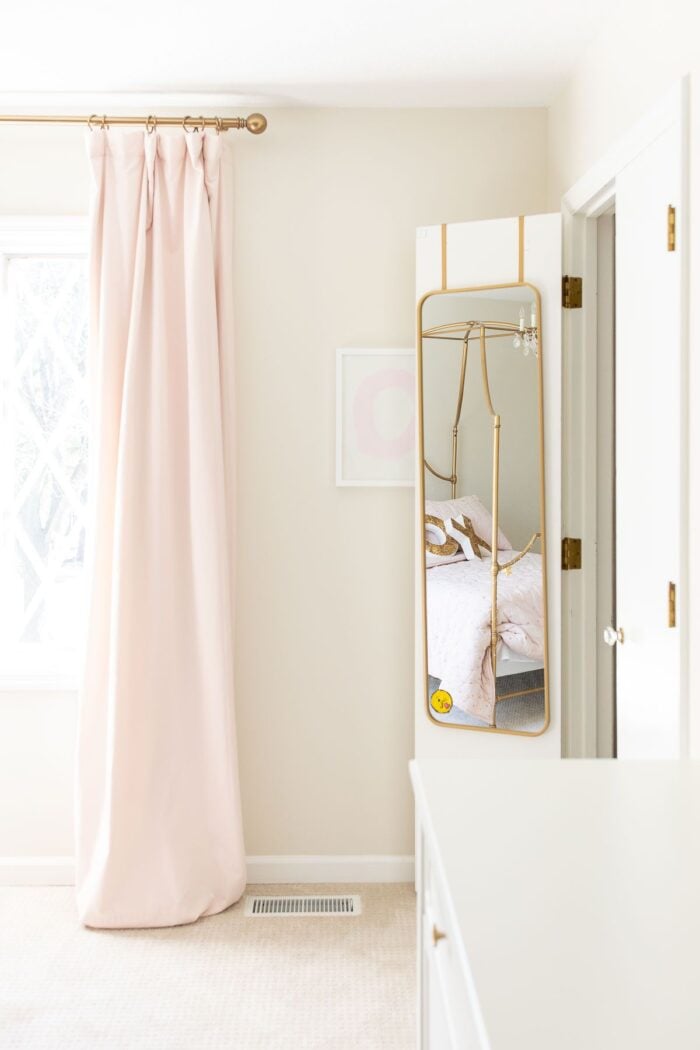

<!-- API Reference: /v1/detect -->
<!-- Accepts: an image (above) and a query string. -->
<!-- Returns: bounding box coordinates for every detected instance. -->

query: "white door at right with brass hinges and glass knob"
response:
[616,127,682,758]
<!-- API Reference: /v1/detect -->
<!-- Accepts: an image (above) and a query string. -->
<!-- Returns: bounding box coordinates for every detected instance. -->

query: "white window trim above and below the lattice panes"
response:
[0,215,88,693]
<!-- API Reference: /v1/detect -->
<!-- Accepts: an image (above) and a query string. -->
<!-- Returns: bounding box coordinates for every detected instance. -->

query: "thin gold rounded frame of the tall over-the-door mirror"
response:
[416,280,550,737]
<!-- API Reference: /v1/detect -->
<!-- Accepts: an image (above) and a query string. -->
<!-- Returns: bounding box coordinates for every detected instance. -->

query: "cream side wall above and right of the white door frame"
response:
[548,0,700,756]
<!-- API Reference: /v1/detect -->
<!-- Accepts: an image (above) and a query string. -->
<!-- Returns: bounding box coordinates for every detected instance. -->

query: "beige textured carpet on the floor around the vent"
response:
[0,885,416,1050]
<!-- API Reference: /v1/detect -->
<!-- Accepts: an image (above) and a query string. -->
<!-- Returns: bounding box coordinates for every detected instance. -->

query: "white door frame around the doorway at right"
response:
[561,78,688,758]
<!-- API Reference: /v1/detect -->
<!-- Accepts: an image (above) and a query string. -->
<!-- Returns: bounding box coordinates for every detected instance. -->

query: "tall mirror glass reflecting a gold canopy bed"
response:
[419,284,549,735]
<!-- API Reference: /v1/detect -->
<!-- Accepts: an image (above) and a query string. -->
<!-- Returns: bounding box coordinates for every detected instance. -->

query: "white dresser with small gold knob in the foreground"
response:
[411,759,700,1050]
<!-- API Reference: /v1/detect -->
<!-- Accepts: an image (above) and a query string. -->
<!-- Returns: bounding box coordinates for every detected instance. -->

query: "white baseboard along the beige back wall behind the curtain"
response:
[0,854,415,886]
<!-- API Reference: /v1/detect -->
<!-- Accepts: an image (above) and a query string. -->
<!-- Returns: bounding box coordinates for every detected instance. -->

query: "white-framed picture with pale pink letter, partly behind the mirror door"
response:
[336,348,416,488]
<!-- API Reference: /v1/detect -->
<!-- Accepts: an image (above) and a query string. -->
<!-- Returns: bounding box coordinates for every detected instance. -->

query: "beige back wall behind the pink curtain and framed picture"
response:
[0,109,546,856]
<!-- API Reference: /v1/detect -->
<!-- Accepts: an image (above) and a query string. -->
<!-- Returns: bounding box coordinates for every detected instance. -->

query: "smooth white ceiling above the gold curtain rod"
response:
[0,0,624,110]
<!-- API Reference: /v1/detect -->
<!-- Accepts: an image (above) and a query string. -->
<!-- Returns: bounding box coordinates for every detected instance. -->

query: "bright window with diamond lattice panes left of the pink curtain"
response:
[0,219,88,688]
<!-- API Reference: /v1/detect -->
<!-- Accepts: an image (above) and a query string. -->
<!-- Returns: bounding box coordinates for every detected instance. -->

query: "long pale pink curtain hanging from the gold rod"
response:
[77,130,246,927]
